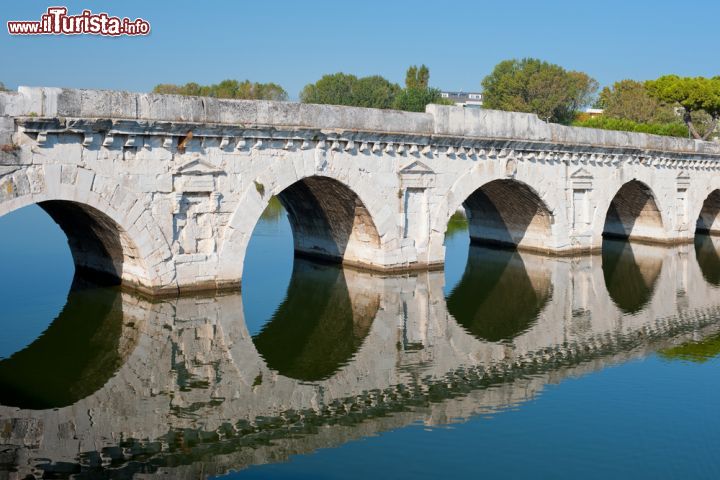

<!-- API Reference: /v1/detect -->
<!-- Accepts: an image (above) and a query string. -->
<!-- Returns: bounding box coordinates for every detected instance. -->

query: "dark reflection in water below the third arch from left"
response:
[447,245,552,342]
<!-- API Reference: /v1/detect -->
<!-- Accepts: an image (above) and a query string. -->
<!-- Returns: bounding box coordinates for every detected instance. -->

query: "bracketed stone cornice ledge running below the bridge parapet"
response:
[12,116,720,166]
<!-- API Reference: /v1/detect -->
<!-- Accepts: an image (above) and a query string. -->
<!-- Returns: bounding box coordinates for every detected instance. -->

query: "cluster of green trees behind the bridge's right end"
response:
[482,58,720,140]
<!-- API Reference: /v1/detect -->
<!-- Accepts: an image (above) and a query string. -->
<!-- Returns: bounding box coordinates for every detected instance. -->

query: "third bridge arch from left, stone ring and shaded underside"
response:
[430,172,555,256]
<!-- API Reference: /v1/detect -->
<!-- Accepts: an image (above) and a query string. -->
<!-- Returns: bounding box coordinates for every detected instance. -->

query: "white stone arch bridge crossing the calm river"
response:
[0,87,720,294]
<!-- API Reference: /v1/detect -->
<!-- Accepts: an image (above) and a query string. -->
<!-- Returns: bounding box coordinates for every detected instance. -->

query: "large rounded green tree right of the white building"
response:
[482,58,598,124]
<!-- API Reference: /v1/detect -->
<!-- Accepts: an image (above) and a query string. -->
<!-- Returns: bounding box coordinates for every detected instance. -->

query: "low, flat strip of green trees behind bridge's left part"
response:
[153,80,288,100]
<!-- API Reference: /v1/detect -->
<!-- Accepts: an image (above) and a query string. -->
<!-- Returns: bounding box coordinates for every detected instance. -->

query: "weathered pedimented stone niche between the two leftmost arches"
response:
[173,159,225,255]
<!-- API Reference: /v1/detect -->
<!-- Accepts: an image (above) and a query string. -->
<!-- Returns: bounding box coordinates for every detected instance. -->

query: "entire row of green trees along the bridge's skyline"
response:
[0,58,708,140]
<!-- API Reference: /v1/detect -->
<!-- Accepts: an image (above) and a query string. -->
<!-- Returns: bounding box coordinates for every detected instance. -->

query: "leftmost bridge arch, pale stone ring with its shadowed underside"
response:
[0,168,176,293]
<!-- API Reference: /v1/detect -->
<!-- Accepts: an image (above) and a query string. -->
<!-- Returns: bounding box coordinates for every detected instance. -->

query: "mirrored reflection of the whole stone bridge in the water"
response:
[0,238,720,478]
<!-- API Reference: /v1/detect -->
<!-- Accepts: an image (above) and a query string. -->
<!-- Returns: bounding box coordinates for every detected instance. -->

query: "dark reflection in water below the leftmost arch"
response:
[0,274,138,410]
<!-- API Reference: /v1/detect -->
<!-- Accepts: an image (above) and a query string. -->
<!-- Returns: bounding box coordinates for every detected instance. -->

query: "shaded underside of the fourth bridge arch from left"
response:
[603,180,663,240]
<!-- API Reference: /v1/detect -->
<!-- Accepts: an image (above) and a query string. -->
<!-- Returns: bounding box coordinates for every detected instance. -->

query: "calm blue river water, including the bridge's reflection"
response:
[0,201,720,479]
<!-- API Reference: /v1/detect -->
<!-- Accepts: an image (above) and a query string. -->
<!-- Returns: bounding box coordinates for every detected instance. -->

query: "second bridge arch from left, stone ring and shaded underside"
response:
[219,169,397,281]
